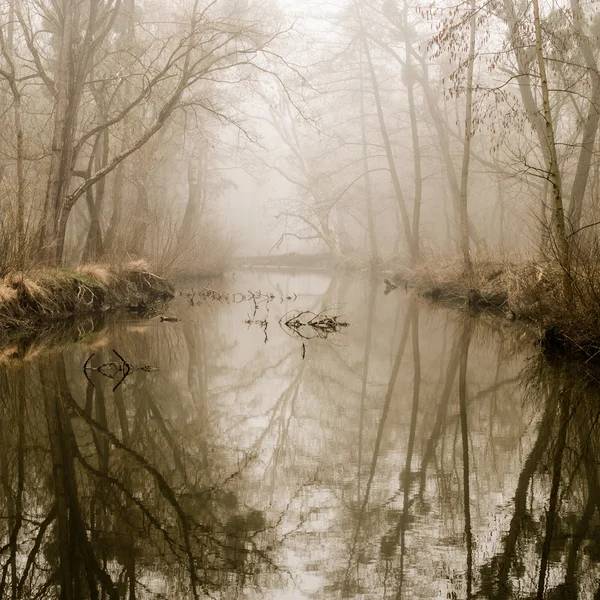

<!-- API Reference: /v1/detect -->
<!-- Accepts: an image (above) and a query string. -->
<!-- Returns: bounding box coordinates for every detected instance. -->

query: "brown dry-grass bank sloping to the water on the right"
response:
[391,261,600,358]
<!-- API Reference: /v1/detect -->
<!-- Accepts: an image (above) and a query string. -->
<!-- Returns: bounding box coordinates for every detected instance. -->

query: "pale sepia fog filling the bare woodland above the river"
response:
[0,0,600,272]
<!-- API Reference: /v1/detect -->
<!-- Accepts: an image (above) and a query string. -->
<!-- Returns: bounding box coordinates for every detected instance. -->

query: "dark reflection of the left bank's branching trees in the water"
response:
[0,344,270,600]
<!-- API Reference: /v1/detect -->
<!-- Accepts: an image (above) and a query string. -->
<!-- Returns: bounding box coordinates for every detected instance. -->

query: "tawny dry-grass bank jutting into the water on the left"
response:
[0,261,173,335]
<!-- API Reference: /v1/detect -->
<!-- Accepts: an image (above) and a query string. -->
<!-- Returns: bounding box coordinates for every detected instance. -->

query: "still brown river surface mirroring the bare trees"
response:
[0,272,600,600]
